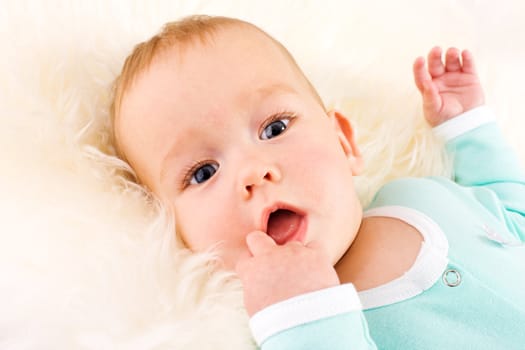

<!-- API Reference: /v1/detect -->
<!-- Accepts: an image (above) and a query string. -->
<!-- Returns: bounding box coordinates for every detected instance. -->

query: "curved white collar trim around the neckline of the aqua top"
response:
[359,206,448,310]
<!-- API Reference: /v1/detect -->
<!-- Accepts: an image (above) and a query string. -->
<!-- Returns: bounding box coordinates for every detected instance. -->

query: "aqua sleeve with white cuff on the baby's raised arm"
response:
[434,106,525,242]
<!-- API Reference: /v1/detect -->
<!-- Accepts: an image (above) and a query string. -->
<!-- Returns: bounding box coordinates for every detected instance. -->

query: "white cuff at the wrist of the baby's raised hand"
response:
[434,106,496,141]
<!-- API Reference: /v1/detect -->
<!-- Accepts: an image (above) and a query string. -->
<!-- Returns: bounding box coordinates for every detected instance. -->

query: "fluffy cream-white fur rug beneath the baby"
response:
[0,0,525,349]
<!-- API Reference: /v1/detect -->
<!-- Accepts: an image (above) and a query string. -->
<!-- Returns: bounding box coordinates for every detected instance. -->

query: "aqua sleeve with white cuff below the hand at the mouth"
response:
[250,284,377,350]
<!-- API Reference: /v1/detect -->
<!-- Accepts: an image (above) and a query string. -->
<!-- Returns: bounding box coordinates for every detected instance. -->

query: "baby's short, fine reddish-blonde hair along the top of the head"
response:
[110,15,324,160]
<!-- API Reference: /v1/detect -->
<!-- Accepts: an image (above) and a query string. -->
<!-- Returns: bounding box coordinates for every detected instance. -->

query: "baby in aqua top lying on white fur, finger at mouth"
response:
[112,16,525,350]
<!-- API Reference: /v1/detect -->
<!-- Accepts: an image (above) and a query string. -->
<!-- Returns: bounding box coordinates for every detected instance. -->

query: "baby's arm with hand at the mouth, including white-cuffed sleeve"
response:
[236,231,376,350]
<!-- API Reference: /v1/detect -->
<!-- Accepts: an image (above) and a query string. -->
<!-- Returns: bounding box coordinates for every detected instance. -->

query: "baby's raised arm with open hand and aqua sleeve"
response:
[414,48,525,241]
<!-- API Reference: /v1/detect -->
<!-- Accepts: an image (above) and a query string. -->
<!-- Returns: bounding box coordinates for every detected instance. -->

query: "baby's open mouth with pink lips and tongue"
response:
[266,209,305,245]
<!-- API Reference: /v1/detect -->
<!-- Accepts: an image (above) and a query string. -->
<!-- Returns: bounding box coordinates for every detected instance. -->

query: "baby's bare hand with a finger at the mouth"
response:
[236,231,340,316]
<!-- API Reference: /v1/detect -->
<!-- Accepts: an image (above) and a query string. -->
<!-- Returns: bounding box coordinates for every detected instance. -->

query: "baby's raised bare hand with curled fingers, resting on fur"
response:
[414,47,485,127]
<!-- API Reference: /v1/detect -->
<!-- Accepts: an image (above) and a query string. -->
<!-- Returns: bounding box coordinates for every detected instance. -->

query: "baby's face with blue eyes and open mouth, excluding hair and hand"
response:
[117,28,361,268]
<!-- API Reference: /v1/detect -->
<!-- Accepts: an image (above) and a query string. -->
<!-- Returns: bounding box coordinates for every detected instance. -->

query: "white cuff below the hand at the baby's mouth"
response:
[250,283,362,346]
